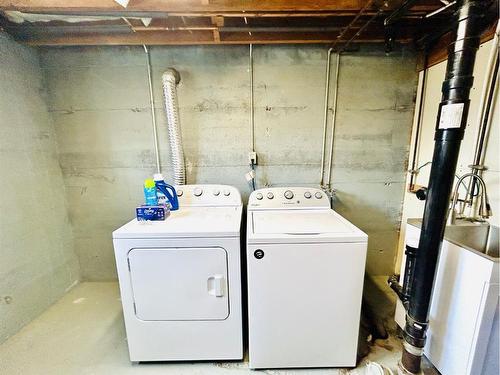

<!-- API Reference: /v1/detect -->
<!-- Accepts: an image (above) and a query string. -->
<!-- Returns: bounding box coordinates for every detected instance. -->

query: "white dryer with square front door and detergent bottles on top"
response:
[113,185,243,362]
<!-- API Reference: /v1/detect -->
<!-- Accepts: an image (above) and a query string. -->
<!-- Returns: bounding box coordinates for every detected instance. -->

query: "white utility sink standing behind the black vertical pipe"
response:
[402,219,500,375]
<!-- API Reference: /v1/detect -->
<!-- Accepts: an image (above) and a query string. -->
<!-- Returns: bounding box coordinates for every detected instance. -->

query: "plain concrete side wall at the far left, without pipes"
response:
[0,33,79,343]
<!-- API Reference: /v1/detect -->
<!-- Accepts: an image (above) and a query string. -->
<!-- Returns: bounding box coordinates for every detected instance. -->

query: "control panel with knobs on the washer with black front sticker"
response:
[248,187,330,210]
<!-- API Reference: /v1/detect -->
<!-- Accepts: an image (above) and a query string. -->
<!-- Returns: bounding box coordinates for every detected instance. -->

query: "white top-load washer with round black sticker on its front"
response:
[247,187,368,368]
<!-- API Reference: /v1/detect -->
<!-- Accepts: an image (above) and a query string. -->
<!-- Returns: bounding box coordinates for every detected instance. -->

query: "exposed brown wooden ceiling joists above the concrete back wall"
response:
[0,0,450,45]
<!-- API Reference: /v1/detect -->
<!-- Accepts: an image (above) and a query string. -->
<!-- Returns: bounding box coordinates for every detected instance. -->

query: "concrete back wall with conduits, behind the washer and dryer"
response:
[41,46,417,280]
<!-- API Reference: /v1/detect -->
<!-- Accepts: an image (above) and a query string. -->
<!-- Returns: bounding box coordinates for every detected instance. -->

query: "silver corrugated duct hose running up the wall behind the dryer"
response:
[162,68,186,185]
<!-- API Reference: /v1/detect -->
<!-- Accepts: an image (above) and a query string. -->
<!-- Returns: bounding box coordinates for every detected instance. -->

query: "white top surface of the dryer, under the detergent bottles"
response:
[113,206,242,239]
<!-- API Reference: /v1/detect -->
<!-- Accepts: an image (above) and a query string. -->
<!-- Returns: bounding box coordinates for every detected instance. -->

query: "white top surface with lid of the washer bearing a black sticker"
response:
[249,209,368,243]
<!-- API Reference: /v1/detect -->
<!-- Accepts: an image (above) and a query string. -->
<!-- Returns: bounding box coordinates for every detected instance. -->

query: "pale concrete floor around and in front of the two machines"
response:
[0,282,426,375]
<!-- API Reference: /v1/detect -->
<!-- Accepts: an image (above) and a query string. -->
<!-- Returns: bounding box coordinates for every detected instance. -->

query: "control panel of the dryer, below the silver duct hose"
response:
[175,184,242,207]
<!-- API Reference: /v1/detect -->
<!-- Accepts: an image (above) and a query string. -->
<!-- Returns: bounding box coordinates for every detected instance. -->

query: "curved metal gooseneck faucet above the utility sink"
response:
[448,173,491,225]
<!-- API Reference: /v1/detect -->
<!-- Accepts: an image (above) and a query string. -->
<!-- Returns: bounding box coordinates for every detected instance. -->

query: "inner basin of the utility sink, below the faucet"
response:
[408,219,500,262]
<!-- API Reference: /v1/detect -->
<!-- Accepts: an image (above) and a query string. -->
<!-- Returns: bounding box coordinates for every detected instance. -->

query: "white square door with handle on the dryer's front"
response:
[128,247,229,320]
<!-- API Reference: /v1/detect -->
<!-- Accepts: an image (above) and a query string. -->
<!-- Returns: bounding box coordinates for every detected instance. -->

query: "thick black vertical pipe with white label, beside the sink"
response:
[400,0,490,374]
